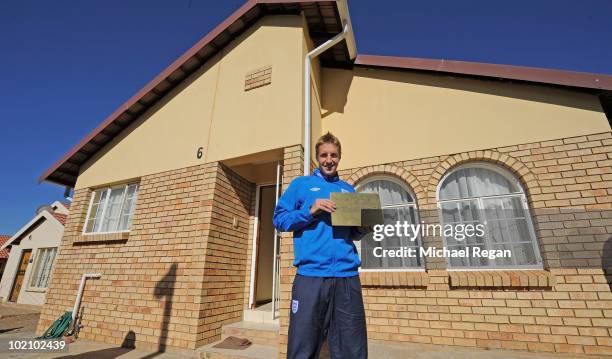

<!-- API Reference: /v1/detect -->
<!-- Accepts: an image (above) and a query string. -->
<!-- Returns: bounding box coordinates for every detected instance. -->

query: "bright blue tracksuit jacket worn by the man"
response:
[273,168,361,277]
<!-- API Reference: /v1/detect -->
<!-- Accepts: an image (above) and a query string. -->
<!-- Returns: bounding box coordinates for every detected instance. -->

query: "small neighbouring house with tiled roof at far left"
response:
[0,201,69,305]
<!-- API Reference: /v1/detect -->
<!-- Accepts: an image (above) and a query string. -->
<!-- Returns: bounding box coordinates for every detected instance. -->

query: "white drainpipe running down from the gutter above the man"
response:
[304,0,357,176]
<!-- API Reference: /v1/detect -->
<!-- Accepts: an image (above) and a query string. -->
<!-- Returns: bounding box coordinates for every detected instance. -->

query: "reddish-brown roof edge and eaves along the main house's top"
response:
[38,0,612,187]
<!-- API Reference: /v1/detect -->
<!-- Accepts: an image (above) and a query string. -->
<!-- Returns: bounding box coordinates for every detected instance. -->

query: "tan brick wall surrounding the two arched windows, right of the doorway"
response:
[280,132,612,357]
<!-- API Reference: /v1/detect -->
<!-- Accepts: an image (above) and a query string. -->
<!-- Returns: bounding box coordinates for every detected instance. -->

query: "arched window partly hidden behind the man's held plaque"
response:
[356,176,423,270]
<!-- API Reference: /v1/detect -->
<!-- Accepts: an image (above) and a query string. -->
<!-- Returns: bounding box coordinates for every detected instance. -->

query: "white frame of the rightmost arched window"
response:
[436,162,544,271]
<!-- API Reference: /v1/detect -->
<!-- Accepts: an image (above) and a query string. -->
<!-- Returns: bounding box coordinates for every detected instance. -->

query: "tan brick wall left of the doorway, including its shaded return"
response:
[37,163,253,349]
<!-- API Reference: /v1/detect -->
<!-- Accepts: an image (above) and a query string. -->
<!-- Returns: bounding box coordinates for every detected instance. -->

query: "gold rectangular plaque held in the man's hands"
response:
[330,192,384,227]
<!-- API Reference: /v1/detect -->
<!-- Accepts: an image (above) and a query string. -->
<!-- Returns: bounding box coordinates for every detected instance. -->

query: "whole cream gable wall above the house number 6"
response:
[75,15,304,189]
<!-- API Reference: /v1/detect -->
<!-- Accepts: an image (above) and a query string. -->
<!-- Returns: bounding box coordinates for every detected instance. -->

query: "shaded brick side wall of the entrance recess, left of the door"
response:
[197,163,255,347]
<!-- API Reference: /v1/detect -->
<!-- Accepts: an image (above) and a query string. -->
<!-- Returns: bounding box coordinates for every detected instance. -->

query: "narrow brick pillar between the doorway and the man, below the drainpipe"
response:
[278,145,304,358]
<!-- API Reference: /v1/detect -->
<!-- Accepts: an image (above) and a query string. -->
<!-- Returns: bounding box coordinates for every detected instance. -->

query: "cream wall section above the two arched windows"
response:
[322,67,610,172]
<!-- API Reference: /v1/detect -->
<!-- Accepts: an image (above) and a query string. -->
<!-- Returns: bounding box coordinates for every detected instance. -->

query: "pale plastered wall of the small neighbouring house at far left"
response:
[0,215,64,305]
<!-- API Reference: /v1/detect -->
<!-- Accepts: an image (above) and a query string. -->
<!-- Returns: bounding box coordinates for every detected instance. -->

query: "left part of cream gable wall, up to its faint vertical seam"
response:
[75,52,219,189]
